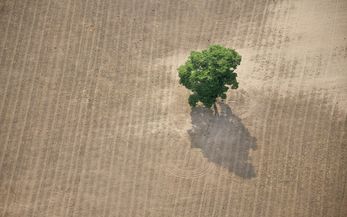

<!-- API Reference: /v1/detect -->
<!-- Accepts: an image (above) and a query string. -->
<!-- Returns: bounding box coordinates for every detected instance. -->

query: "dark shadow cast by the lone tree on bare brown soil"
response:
[188,103,256,179]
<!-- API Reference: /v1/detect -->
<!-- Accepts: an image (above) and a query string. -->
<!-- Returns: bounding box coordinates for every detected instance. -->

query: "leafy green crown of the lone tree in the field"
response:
[178,45,241,108]
